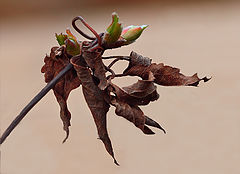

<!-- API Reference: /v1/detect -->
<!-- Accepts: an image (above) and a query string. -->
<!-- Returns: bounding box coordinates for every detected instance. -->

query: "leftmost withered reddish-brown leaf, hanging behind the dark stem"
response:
[41,46,81,142]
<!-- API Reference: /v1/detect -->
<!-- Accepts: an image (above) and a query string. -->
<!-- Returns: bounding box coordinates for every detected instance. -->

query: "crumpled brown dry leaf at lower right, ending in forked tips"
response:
[110,72,165,134]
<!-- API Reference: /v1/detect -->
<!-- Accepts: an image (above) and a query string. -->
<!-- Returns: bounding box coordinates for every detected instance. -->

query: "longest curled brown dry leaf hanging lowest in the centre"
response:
[71,56,119,165]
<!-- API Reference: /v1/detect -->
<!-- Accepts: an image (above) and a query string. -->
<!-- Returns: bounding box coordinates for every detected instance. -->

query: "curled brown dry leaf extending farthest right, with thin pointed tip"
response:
[124,52,209,86]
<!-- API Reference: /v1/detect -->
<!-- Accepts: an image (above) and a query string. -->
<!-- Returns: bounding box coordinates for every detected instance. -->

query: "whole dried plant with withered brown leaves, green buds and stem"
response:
[0,13,209,165]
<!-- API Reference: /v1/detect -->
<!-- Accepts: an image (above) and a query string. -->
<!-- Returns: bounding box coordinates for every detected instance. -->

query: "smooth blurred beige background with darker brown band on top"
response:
[0,0,240,174]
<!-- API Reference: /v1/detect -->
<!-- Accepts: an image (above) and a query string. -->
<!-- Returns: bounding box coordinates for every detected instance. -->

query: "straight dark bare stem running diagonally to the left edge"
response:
[0,63,73,144]
